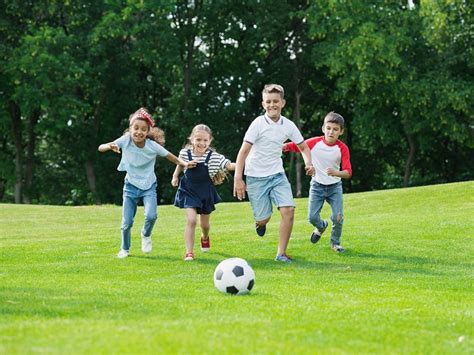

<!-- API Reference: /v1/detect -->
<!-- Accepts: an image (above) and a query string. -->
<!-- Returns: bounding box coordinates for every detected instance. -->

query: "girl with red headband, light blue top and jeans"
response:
[99,108,196,259]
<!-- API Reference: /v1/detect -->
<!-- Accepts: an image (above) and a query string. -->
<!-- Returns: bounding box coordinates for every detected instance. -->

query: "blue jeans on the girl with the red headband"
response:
[121,182,157,251]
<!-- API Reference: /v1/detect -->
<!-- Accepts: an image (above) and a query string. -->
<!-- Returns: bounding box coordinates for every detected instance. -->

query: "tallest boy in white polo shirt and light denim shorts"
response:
[234,84,314,263]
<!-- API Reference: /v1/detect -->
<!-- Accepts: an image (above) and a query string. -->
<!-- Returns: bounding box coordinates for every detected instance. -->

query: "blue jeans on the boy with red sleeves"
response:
[308,181,344,244]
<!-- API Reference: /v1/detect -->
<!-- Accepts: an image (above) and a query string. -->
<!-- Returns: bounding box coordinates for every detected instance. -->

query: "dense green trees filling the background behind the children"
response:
[0,0,474,204]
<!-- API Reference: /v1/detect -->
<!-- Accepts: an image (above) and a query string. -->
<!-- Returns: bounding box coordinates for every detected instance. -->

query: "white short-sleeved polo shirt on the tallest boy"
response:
[244,115,304,177]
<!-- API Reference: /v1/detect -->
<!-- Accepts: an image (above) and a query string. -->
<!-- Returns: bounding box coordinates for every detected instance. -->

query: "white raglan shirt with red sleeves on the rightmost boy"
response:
[283,136,352,185]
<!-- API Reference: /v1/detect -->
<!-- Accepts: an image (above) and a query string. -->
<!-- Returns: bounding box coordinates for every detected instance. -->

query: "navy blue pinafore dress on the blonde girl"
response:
[174,149,222,214]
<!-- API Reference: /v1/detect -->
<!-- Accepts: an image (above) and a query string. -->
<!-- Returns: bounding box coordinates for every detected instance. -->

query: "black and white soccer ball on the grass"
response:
[214,258,255,295]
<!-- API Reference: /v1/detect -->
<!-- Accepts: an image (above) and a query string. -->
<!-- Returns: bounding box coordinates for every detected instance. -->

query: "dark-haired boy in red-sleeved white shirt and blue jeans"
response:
[283,112,352,253]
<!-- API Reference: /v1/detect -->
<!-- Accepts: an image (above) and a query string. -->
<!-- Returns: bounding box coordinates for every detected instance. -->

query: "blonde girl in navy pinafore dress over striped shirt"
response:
[171,124,235,261]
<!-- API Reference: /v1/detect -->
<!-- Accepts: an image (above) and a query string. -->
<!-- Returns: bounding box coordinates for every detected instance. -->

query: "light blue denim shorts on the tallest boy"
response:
[246,173,295,221]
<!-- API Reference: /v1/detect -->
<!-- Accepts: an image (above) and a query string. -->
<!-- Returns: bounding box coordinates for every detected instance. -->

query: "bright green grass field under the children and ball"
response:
[0,181,474,354]
